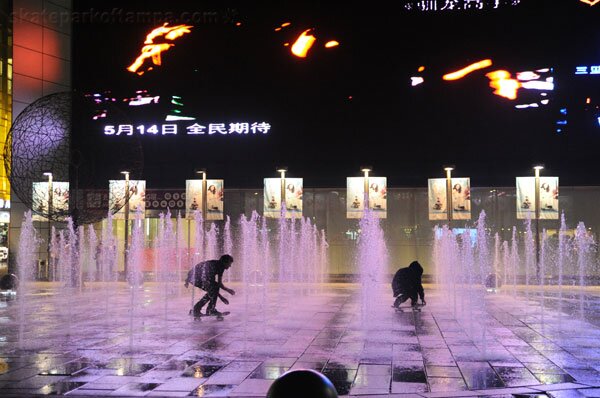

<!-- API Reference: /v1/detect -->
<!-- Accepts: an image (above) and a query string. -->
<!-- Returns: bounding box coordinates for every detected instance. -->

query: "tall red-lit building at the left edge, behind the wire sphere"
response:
[6,0,72,274]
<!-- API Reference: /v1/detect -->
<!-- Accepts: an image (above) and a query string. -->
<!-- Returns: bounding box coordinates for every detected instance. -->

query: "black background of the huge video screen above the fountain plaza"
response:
[73,0,600,188]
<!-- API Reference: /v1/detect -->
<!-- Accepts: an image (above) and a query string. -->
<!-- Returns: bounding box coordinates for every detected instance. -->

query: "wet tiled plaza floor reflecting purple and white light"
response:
[0,283,600,398]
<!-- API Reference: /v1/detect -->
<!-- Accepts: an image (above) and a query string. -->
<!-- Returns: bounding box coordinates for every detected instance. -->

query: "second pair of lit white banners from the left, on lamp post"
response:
[108,180,146,220]
